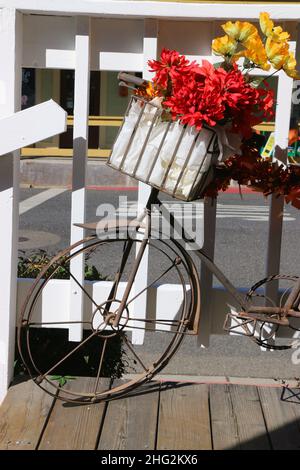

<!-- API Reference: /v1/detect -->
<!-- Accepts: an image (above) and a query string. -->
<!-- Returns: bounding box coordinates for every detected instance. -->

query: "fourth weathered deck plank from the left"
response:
[157,384,212,450]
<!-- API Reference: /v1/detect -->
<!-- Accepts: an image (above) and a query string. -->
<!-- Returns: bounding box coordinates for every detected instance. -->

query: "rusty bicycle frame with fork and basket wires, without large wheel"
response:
[108,72,300,336]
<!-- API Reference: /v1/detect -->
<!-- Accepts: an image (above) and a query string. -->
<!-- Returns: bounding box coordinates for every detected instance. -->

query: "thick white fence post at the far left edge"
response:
[0,8,22,403]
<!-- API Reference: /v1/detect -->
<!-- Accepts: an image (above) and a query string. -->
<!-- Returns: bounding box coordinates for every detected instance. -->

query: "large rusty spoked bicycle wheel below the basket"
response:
[18,232,200,403]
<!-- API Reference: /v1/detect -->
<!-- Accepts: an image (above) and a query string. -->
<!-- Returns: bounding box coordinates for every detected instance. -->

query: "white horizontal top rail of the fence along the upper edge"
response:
[7,0,300,21]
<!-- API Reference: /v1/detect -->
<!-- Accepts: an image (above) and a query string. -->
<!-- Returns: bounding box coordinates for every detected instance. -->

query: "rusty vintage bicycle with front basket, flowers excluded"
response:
[18,73,300,403]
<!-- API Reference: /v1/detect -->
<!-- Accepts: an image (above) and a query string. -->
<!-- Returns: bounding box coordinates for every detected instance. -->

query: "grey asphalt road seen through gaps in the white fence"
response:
[19,189,300,378]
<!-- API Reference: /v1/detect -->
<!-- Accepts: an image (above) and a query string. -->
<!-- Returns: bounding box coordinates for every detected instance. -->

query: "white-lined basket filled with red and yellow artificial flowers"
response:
[109,13,299,200]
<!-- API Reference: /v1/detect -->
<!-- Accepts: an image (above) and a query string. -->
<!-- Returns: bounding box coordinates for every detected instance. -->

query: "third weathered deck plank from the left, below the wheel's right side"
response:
[98,380,159,450]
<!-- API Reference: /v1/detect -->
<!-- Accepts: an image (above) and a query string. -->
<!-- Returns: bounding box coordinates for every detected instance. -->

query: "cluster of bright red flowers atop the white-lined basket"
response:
[149,49,274,138]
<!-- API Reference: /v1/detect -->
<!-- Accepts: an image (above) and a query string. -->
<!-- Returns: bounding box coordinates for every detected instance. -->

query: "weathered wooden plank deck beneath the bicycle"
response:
[0,378,300,450]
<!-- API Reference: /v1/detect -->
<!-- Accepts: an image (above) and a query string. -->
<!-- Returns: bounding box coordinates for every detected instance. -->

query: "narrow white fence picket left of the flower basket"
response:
[69,16,90,341]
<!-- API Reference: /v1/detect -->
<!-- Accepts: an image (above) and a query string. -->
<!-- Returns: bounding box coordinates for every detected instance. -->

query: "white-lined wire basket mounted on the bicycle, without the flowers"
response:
[107,96,219,201]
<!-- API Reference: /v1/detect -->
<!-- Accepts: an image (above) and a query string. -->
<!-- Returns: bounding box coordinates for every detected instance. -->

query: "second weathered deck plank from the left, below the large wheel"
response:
[38,377,109,450]
